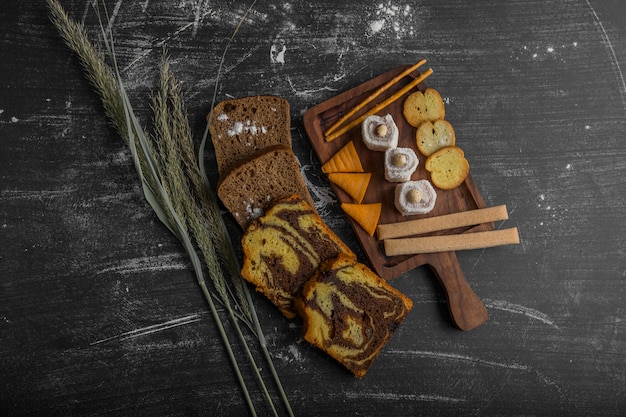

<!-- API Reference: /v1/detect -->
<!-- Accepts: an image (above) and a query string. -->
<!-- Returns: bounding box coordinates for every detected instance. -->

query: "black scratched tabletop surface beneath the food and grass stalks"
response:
[0,0,626,416]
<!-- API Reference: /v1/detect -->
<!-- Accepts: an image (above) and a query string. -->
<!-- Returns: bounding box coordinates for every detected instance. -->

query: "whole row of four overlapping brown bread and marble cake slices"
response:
[209,96,413,378]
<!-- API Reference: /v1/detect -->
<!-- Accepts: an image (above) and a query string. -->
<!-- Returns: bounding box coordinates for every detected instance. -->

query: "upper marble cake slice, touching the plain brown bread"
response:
[241,196,355,318]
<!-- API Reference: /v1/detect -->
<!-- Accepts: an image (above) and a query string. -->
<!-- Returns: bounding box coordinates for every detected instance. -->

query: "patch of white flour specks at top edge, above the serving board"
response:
[369,1,415,39]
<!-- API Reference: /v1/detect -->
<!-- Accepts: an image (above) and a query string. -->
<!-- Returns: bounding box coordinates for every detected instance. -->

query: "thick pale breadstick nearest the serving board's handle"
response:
[384,227,519,256]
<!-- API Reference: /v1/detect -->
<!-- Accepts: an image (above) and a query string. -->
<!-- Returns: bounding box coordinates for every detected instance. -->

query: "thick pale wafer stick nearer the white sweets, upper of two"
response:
[377,205,509,239]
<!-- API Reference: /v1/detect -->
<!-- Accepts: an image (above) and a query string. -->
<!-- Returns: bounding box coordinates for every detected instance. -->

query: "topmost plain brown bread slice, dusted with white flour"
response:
[209,96,291,178]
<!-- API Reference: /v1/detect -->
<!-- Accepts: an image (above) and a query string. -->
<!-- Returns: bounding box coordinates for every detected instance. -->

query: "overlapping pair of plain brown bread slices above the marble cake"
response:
[209,96,313,230]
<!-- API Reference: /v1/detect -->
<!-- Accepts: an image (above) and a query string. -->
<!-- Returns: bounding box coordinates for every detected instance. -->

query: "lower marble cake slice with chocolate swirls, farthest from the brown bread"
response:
[296,255,413,378]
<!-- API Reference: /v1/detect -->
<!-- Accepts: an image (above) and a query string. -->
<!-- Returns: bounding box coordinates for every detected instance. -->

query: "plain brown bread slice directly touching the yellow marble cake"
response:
[217,145,315,230]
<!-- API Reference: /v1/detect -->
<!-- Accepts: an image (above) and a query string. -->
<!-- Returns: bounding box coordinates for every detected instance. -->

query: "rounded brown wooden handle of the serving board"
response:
[428,252,489,330]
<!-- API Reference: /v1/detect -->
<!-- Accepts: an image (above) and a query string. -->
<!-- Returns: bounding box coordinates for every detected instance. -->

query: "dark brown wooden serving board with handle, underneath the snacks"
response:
[303,66,494,330]
